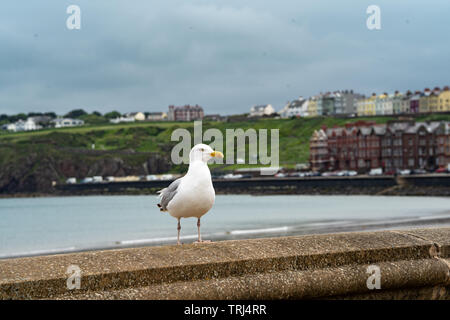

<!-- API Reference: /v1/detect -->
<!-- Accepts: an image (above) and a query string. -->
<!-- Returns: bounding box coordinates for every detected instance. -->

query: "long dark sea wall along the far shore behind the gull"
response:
[55,174,450,196]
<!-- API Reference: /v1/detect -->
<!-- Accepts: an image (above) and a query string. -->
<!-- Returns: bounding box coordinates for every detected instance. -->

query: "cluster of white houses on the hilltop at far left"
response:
[2,116,84,132]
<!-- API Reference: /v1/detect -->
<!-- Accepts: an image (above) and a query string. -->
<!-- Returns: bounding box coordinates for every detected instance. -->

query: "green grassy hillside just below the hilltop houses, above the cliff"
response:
[0,115,450,164]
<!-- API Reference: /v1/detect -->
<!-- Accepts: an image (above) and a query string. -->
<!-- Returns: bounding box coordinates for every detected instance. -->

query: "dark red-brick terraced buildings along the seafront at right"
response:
[310,121,450,172]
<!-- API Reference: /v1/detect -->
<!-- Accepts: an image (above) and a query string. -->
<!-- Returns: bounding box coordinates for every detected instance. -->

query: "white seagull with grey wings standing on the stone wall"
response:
[158,144,223,244]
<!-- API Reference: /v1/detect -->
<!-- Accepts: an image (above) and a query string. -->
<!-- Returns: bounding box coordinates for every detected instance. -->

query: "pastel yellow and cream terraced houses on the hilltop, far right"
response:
[357,86,450,116]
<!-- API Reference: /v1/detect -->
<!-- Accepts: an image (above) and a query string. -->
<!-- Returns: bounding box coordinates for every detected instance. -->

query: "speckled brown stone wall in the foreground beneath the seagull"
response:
[0,228,450,299]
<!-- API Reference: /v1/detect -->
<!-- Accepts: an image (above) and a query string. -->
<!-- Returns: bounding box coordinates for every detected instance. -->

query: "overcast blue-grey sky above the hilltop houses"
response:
[0,0,450,114]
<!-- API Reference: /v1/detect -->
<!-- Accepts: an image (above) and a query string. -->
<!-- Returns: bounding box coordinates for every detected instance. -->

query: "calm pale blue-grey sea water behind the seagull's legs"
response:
[0,195,450,258]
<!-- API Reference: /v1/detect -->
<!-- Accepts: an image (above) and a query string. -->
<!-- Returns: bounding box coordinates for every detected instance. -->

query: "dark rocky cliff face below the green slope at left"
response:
[0,149,171,195]
